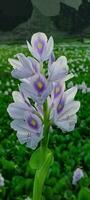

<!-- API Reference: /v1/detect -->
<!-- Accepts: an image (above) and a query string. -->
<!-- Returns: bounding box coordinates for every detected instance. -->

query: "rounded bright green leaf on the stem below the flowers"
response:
[29,147,50,169]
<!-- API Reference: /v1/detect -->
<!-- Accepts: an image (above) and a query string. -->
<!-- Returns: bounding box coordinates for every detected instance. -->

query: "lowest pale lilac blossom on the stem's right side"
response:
[51,86,80,132]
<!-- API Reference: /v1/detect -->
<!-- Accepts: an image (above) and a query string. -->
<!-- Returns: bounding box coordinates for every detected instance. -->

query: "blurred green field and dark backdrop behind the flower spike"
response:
[0,0,90,200]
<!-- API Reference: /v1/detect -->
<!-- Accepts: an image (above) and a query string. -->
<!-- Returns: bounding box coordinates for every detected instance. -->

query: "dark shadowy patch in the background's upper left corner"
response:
[0,0,33,31]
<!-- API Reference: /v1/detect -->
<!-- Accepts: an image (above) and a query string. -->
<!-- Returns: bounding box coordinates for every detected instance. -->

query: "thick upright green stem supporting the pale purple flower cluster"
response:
[33,101,53,200]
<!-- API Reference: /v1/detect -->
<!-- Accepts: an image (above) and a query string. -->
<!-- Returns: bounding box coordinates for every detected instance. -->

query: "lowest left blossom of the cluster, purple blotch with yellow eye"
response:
[7,92,43,149]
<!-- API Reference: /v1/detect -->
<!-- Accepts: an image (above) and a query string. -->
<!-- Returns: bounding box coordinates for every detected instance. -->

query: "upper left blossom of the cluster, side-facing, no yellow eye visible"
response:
[8,53,40,79]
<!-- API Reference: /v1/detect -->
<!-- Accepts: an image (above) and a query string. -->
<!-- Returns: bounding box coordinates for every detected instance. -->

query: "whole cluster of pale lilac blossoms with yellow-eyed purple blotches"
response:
[7,33,80,149]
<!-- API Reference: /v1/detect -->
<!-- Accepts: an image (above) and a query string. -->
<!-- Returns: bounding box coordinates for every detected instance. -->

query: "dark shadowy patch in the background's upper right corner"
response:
[53,0,90,34]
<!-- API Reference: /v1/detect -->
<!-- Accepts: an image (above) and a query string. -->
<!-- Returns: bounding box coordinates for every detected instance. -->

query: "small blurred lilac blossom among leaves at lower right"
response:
[72,168,84,185]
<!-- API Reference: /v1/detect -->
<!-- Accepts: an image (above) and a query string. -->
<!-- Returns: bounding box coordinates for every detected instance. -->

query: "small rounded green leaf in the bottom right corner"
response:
[78,188,90,200]
